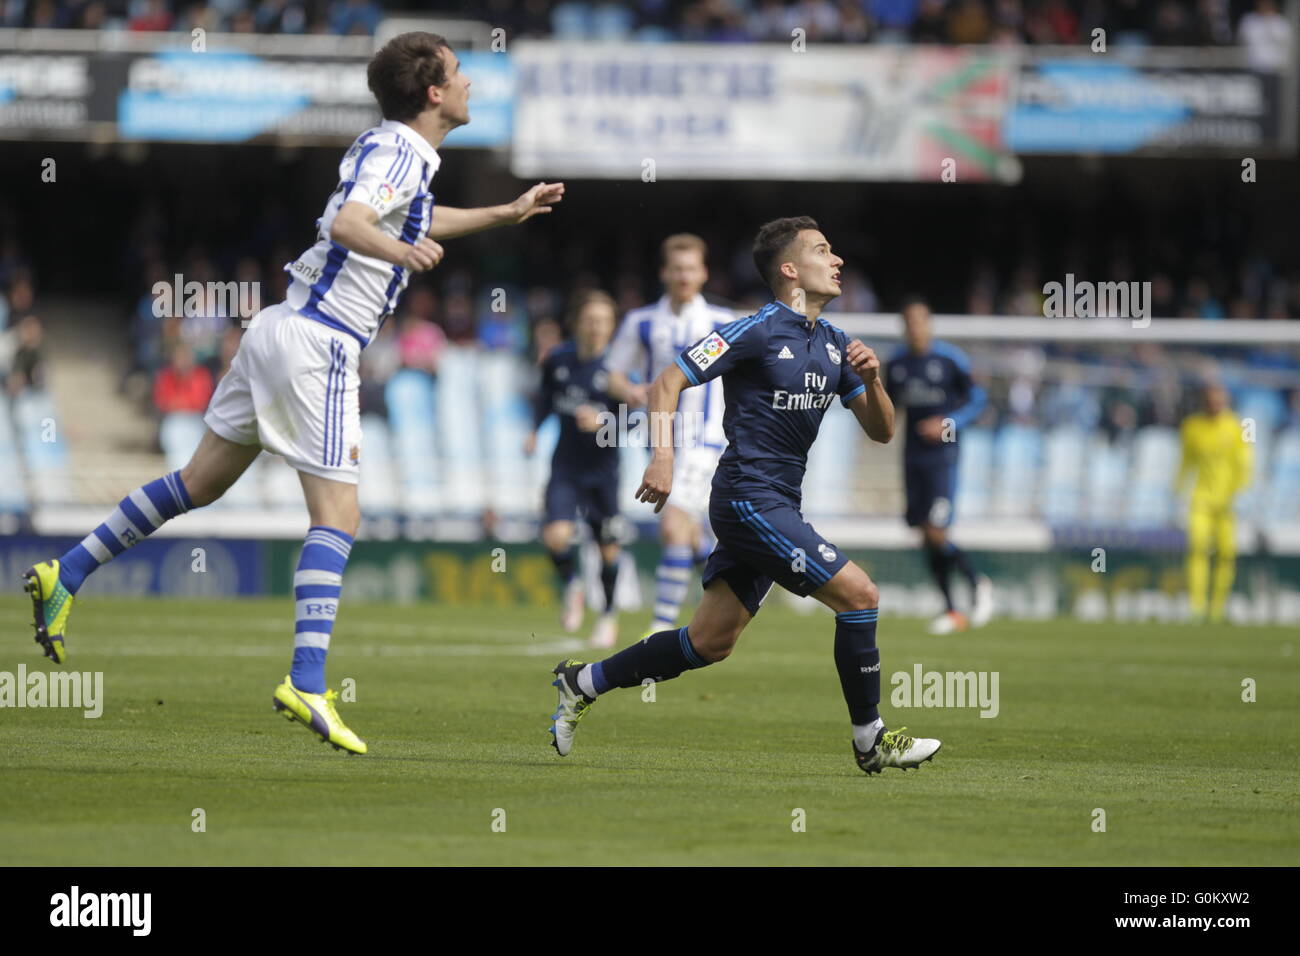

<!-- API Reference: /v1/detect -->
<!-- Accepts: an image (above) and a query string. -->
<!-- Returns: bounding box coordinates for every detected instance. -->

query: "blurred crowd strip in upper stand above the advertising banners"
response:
[0,0,1291,56]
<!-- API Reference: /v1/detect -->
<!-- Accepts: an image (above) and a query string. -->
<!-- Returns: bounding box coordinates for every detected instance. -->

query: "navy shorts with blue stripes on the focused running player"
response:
[703,493,849,614]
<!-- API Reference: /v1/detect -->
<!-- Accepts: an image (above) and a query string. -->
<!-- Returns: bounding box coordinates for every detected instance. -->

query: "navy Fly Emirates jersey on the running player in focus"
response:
[677,302,866,505]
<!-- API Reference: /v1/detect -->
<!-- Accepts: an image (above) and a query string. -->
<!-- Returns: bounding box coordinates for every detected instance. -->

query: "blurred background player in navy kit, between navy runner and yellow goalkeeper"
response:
[885,299,993,633]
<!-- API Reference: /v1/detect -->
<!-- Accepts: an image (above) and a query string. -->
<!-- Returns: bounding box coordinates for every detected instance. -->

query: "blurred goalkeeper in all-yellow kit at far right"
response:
[1177,384,1251,620]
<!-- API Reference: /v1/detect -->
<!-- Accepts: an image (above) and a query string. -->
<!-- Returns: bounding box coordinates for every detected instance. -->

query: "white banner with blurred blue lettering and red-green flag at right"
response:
[512,42,1018,181]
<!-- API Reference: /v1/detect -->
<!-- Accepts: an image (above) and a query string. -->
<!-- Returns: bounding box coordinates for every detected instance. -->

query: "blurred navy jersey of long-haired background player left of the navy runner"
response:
[533,342,619,472]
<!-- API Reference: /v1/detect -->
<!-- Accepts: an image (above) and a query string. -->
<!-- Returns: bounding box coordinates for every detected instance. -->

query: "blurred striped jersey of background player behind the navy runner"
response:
[605,295,735,450]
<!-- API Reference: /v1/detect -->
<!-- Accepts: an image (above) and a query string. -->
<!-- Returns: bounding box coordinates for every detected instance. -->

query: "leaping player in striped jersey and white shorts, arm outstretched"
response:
[25,33,564,753]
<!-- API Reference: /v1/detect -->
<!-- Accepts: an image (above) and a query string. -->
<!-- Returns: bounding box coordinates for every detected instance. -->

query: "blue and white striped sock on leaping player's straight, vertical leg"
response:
[289,525,352,693]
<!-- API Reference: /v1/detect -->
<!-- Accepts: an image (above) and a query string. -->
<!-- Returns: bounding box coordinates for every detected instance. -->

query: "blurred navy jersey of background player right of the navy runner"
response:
[884,341,985,458]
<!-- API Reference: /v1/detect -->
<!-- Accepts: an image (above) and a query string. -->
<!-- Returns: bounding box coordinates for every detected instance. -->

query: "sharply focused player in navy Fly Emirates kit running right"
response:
[551,216,940,774]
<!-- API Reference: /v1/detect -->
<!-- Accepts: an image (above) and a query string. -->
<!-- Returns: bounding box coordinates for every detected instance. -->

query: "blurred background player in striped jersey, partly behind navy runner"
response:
[607,233,733,633]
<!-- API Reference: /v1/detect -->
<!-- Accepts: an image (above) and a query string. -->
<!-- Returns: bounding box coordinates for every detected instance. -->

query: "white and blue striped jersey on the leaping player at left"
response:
[285,120,442,346]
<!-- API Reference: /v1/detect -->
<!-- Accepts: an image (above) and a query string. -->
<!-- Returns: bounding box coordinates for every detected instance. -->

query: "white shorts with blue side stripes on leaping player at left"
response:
[203,302,361,485]
